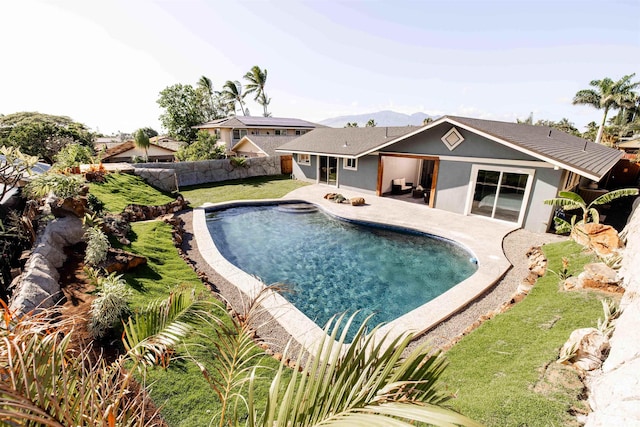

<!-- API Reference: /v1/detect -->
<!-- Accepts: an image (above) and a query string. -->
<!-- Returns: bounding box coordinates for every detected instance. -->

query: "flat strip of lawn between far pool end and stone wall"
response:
[180,175,309,207]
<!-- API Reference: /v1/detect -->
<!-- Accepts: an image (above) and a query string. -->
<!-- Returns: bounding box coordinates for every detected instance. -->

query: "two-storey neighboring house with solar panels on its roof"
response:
[194,116,324,149]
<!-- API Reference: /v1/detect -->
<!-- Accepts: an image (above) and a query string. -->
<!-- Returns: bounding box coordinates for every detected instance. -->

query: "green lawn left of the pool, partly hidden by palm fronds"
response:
[125,221,279,426]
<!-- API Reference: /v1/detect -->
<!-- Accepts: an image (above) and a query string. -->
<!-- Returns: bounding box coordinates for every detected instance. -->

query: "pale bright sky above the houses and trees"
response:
[0,0,640,134]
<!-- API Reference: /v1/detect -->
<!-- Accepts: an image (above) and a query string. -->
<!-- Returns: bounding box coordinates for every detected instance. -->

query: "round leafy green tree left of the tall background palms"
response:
[157,83,205,142]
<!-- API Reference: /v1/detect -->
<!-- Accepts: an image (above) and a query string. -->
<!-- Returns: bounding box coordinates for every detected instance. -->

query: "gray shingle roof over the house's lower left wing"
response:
[278,126,420,157]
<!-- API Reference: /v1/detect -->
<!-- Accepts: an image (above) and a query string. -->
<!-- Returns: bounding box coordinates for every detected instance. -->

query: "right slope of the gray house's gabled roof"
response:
[442,116,622,180]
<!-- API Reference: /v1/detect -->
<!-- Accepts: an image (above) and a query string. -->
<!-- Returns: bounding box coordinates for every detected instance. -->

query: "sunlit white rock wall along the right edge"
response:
[585,203,640,427]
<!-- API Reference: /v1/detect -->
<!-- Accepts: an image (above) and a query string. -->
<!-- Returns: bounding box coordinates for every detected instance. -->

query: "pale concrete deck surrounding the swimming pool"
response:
[193,185,518,350]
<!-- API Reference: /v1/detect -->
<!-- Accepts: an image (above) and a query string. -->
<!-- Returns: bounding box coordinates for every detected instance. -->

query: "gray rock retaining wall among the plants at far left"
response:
[9,216,84,314]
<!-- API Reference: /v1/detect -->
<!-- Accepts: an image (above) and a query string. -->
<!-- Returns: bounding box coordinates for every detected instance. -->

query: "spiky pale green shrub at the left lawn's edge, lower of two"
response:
[89,273,131,338]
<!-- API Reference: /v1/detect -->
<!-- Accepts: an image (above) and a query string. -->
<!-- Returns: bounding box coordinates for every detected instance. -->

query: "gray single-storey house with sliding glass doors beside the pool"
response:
[276,116,622,232]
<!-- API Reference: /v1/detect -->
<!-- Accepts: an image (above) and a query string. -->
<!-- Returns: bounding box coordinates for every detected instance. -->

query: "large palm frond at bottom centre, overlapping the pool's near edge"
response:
[255,315,477,426]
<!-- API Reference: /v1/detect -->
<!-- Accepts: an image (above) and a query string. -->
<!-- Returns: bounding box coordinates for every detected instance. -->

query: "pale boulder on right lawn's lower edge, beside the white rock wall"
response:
[560,328,609,371]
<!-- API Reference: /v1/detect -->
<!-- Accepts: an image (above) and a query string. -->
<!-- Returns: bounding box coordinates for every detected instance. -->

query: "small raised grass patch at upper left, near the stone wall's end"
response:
[89,173,175,213]
